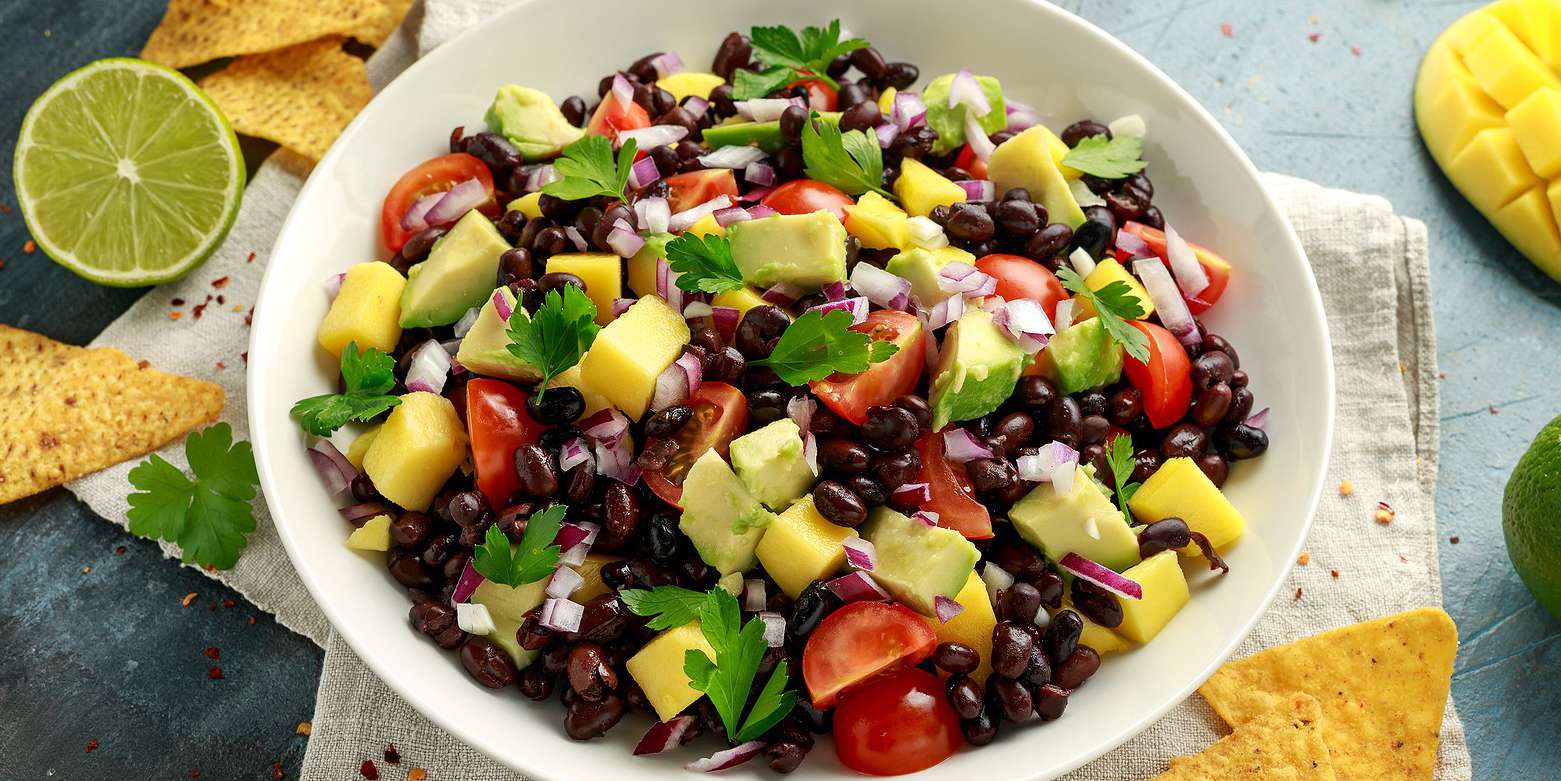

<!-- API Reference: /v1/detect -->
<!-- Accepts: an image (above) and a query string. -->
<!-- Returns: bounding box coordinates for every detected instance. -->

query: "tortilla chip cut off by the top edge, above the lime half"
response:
[140,0,390,67]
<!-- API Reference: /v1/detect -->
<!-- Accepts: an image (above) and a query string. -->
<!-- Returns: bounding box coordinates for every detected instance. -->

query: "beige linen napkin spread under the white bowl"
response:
[60,0,1472,781]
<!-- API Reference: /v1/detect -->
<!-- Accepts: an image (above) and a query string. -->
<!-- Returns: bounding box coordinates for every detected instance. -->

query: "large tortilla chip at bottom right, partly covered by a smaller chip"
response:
[1199,608,1458,779]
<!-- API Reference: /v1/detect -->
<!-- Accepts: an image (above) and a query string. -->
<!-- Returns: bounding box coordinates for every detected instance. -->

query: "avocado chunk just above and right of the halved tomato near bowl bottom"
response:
[862,508,980,615]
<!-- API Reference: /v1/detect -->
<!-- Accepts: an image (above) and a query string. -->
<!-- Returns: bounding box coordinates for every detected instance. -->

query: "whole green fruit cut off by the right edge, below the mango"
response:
[1502,417,1561,619]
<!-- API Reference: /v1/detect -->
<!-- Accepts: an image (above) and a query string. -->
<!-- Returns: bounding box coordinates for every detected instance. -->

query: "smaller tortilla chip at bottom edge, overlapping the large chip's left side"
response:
[1152,694,1336,781]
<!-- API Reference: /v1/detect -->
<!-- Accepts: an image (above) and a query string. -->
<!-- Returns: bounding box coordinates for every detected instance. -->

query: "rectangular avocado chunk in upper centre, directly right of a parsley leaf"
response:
[727,211,846,289]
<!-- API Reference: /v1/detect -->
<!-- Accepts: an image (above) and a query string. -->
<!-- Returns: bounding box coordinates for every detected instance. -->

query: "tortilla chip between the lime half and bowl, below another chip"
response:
[200,37,375,162]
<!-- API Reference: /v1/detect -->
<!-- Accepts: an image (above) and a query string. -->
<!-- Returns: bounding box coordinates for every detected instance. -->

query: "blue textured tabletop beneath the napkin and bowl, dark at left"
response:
[0,0,1561,779]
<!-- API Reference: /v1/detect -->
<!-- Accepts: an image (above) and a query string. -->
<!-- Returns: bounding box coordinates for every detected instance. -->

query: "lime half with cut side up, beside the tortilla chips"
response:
[12,58,244,287]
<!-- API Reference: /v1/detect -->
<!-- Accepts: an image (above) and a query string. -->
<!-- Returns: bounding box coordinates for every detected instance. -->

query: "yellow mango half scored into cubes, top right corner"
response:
[1414,0,1561,281]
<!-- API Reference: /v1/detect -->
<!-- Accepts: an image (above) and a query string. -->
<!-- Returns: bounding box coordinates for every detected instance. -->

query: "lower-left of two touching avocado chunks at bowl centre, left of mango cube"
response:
[677,448,774,575]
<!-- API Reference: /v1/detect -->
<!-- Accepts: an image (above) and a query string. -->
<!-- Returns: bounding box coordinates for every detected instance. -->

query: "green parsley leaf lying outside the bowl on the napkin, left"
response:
[128,423,261,570]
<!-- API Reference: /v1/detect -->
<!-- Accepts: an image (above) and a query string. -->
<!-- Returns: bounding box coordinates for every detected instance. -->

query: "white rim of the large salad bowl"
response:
[245,0,1336,779]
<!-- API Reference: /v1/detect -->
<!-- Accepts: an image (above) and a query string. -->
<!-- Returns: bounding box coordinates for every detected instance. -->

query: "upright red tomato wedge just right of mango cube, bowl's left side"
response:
[467,380,548,508]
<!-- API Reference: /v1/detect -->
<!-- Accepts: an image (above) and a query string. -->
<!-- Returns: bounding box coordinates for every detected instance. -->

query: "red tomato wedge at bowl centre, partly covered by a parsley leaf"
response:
[809,309,927,425]
